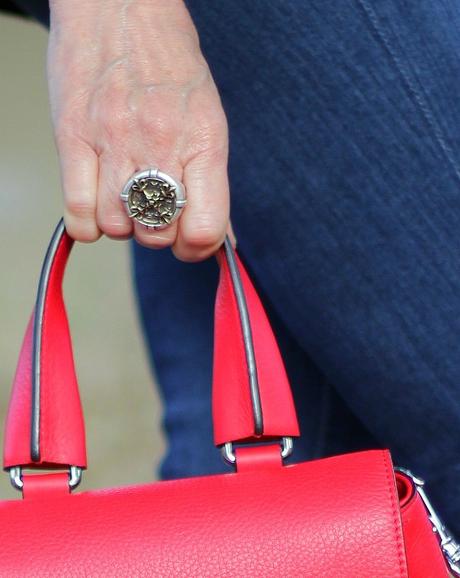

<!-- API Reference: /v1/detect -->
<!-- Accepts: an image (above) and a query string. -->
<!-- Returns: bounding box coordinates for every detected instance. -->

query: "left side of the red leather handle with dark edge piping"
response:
[3,220,82,468]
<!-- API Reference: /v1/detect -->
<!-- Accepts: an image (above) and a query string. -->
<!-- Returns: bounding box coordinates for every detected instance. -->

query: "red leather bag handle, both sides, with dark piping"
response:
[4,220,299,476]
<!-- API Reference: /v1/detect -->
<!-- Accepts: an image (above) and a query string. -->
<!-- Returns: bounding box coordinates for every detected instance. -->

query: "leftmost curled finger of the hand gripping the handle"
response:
[58,138,101,242]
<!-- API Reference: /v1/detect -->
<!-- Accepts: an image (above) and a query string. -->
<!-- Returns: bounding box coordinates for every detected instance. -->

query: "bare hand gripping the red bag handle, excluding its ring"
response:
[48,0,234,261]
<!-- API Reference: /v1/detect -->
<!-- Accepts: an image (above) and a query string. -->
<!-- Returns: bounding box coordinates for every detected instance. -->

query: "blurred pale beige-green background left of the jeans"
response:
[0,16,165,498]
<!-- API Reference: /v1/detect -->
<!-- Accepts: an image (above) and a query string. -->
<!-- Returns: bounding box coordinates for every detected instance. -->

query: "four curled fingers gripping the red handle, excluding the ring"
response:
[60,140,230,261]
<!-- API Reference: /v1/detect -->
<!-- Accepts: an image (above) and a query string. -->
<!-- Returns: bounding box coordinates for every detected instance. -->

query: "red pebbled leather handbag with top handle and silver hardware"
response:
[0,221,460,578]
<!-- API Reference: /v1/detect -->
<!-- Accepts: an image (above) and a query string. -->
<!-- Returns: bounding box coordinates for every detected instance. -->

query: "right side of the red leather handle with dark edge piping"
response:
[213,239,299,446]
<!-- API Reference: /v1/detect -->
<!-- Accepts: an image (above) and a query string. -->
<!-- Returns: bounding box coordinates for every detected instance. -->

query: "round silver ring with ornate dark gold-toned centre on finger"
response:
[120,168,187,229]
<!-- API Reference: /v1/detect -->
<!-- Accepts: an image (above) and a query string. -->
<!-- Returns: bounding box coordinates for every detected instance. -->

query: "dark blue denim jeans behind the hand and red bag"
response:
[18,0,460,535]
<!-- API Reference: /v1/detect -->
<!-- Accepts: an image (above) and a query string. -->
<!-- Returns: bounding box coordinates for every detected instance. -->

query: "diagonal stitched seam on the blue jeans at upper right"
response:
[356,0,460,181]
